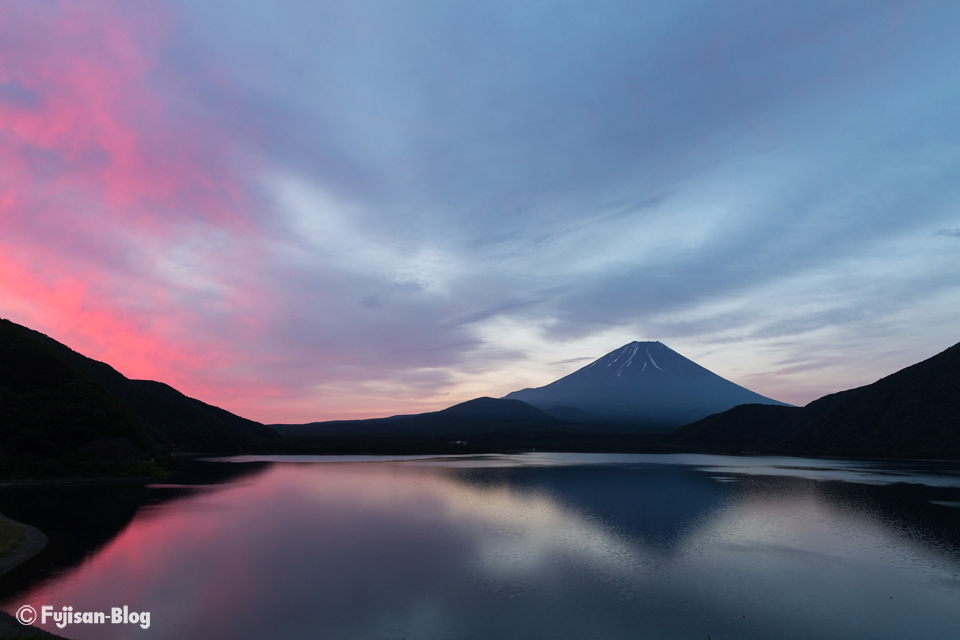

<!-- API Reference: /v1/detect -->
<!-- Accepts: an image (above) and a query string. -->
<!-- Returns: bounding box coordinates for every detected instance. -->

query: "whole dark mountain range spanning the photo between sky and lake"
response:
[0,320,960,462]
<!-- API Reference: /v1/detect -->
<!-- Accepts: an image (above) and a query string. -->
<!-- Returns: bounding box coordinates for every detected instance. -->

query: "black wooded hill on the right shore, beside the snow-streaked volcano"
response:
[671,344,960,458]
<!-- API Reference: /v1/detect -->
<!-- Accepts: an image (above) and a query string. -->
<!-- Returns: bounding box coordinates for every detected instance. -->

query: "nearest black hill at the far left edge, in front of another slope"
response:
[0,320,159,476]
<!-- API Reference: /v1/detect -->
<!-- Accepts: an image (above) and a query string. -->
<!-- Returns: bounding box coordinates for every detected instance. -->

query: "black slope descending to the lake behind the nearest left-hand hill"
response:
[9,322,278,453]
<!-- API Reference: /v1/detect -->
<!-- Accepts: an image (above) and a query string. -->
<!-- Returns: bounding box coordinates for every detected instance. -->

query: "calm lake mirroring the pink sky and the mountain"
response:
[0,453,960,640]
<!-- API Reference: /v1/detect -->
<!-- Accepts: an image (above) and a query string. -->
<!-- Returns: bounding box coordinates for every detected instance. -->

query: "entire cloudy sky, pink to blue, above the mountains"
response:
[0,0,960,423]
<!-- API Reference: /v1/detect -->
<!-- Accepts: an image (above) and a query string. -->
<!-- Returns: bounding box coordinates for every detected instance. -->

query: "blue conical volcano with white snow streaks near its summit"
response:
[505,342,789,425]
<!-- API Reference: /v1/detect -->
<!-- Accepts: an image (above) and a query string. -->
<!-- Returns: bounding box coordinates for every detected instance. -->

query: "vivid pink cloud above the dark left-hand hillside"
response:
[0,2,274,404]
